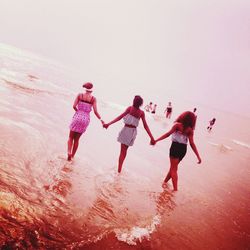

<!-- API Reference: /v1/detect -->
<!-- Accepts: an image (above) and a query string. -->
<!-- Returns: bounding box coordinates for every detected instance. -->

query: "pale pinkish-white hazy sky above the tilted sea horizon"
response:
[0,0,250,116]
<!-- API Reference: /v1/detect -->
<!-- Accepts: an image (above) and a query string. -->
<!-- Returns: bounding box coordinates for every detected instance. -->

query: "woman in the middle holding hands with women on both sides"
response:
[103,95,154,173]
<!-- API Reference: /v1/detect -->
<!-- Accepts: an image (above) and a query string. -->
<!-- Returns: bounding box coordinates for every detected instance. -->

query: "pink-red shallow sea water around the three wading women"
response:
[0,46,250,249]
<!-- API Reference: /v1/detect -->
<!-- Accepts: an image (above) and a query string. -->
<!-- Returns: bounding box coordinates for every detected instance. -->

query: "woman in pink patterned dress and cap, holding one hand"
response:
[68,82,104,161]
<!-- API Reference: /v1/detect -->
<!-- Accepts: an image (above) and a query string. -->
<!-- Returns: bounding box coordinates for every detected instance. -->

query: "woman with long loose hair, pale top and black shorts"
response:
[151,111,201,191]
